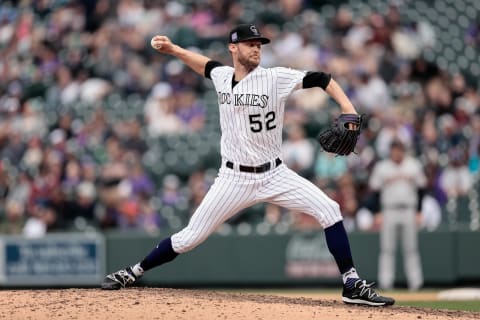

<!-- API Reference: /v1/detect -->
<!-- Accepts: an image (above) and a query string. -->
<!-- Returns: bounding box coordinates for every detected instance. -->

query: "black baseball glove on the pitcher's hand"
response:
[317,113,363,156]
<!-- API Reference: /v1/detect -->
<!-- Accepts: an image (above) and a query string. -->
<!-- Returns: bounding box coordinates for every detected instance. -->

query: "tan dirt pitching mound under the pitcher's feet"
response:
[0,288,478,320]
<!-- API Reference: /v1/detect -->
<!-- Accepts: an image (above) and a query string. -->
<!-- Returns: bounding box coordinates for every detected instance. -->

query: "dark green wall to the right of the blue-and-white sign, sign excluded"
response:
[106,231,480,286]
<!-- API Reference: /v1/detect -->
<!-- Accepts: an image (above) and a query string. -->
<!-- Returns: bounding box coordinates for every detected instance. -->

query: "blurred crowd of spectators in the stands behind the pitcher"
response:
[0,0,480,236]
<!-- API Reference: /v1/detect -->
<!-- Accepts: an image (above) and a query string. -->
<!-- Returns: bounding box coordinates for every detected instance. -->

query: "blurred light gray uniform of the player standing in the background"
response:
[370,152,426,289]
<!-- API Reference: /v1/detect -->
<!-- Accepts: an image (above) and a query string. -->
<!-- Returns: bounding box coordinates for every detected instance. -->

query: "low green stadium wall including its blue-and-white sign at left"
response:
[0,231,480,287]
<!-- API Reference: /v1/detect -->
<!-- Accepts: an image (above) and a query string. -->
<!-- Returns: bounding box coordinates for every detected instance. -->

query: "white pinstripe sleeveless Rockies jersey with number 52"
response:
[210,66,306,166]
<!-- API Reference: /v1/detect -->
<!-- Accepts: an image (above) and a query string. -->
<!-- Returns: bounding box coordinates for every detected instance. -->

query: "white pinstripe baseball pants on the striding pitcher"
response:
[171,161,342,253]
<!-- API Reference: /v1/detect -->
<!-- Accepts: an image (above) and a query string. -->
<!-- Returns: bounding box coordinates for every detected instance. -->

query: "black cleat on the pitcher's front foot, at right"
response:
[342,279,395,307]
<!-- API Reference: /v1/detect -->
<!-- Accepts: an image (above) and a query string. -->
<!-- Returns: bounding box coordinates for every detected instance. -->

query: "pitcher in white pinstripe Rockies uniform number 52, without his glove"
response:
[102,25,394,306]
